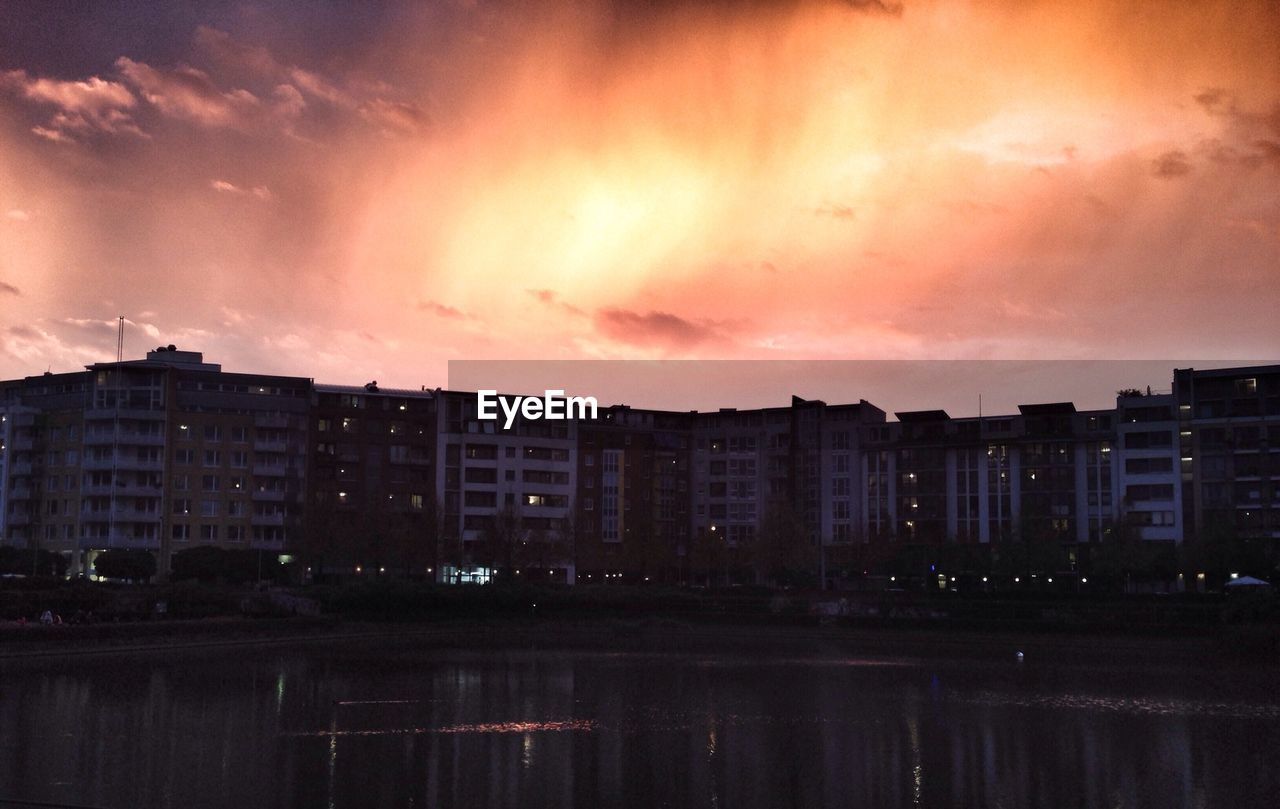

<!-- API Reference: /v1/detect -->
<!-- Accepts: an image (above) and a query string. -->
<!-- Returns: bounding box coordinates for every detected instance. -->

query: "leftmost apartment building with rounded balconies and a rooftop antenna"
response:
[0,346,311,576]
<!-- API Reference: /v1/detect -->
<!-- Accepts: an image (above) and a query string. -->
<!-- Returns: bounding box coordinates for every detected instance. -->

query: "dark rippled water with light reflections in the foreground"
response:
[0,641,1280,809]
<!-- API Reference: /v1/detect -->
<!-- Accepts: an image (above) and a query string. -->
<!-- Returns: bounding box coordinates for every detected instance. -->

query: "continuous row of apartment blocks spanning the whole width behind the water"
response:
[0,355,1280,582]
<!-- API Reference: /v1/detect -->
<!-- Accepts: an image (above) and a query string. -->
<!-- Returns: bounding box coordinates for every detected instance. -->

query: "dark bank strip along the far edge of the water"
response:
[0,618,1280,667]
